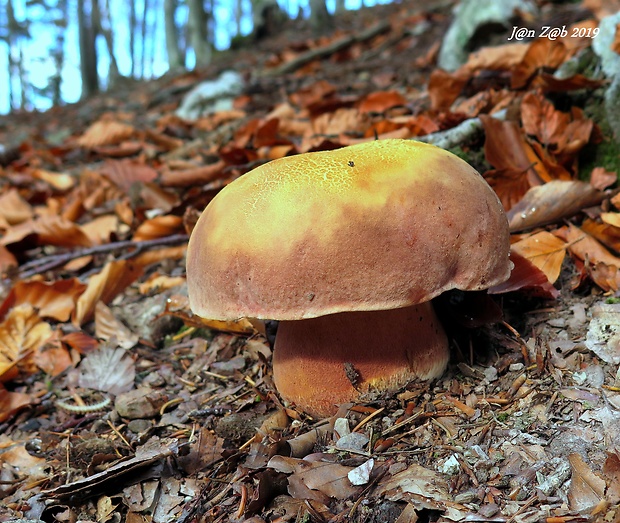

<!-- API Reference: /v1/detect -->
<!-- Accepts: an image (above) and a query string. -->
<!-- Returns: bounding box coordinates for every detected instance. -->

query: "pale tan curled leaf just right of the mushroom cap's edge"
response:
[507,180,605,232]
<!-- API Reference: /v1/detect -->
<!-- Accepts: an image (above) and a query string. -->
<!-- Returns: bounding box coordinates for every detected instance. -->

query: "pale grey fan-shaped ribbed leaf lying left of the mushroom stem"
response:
[78,347,136,396]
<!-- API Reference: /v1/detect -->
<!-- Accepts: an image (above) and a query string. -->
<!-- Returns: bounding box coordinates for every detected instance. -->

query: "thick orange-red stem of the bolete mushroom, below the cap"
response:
[273,302,450,417]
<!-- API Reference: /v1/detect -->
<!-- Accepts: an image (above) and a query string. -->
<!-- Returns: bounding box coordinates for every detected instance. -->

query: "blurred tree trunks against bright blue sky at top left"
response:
[0,0,382,114]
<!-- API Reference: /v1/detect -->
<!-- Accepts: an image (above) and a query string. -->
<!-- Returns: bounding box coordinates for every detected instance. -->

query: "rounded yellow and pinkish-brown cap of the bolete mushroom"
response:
[187,140,511,320]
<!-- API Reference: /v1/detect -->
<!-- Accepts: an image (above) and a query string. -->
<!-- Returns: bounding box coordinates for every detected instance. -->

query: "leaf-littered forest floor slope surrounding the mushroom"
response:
[0,2,620,523]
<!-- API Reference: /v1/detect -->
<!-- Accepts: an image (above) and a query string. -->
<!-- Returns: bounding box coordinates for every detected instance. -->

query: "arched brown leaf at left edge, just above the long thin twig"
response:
[0,216,92,247]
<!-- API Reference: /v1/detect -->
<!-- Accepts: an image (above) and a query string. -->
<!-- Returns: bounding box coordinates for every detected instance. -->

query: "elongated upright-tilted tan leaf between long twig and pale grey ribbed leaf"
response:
[72,260,143,326]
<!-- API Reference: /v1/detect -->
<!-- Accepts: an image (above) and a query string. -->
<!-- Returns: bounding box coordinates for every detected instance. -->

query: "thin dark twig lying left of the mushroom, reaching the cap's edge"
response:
[18,234,189,279]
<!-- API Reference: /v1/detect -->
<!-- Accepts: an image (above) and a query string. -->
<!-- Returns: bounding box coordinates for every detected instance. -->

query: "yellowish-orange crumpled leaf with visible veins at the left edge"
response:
[0,304,52,381]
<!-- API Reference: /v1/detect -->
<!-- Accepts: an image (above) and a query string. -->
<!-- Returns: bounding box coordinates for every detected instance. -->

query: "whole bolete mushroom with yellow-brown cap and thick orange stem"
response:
[187,140,511,416]
